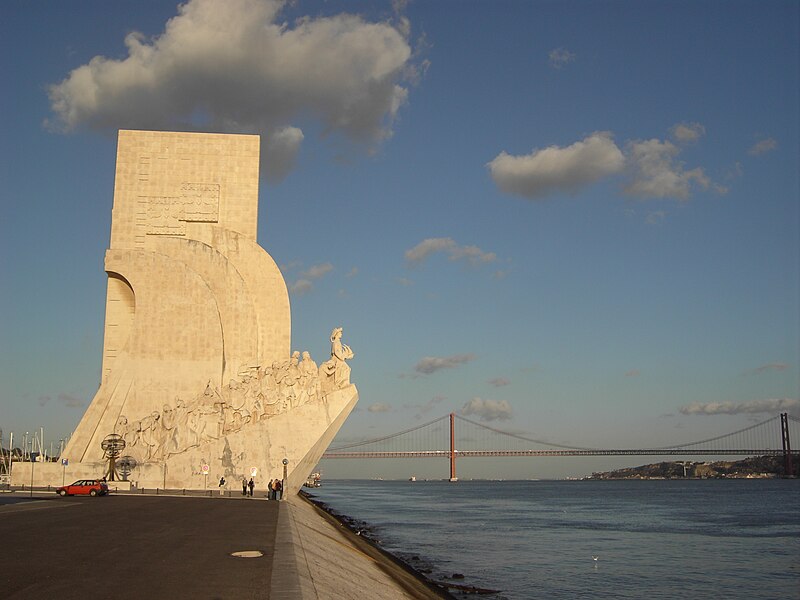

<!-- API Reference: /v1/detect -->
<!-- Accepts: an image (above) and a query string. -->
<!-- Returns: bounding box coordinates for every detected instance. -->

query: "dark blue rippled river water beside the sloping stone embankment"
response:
[311,479,800,600]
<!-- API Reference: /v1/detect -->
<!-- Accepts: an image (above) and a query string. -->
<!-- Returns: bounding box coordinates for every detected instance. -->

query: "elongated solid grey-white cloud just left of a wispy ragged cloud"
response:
[487,131,625,200]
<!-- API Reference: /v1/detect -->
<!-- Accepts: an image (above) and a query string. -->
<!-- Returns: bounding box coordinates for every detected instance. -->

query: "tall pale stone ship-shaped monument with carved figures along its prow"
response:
[14,130,358,494]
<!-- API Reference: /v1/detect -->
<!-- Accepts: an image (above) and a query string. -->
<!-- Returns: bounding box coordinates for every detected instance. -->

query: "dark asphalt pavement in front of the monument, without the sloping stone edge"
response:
[0,494,279,600]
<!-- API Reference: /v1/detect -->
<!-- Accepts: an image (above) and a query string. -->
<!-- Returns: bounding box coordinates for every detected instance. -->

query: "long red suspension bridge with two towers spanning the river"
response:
[323,413,800,481]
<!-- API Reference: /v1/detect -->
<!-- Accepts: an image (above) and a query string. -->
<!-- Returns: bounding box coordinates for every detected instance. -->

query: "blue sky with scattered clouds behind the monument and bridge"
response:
[0,0,800,477]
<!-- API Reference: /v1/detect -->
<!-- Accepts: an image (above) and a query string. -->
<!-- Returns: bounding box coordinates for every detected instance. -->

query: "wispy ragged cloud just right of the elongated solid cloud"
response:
[624,139,727,200]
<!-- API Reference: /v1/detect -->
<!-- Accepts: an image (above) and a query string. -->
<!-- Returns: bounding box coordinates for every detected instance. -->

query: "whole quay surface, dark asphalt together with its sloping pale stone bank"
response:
[0,493,441,600]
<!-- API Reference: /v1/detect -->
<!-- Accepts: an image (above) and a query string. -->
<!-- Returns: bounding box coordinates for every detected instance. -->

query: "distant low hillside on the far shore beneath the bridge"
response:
[587,453,800,479]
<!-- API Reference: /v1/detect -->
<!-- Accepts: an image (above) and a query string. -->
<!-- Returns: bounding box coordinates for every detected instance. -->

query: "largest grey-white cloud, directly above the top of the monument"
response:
[46,0,415,178]
